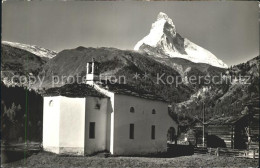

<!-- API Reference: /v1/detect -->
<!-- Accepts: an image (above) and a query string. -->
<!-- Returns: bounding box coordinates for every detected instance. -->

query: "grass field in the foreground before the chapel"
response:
[2,152,258,168]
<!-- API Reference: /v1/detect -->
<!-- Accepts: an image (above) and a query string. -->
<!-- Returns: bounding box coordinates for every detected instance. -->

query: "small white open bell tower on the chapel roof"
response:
[86,58,99,85]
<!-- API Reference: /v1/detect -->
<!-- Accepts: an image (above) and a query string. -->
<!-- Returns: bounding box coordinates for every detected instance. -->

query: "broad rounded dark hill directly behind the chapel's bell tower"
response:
[43,47,194,102]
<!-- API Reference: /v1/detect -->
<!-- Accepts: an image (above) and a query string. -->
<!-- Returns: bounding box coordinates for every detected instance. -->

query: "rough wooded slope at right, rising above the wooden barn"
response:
[174,56,260,125]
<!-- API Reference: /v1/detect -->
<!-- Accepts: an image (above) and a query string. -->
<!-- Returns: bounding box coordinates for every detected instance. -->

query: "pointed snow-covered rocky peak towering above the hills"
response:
[134,12,228,68]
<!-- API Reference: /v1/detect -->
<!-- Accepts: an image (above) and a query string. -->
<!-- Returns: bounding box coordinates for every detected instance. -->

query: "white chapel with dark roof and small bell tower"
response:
[43,60,178,155]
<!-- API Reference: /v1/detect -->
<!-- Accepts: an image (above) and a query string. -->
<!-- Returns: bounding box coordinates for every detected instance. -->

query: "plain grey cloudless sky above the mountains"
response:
[2,1,259,65]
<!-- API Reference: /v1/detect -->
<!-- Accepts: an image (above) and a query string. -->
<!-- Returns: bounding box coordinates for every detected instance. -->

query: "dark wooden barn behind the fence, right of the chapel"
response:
[178,102,260,150]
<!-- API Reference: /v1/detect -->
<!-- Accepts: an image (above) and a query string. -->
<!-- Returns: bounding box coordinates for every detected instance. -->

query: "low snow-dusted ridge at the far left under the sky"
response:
[2,41,57,59]
